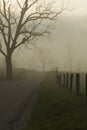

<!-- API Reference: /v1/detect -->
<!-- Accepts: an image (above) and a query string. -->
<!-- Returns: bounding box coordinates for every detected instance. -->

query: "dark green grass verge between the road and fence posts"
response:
[26,72,87,130]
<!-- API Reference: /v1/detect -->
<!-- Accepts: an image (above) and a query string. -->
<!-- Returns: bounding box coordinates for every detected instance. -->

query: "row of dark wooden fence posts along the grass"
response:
[56,72,87,103]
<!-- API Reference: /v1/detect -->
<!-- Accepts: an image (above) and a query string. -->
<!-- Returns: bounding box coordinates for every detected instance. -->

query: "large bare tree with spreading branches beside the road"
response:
[0,0,64,79]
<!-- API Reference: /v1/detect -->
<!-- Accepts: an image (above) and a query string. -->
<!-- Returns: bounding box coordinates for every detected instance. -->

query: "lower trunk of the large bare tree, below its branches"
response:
[6,54,12,80]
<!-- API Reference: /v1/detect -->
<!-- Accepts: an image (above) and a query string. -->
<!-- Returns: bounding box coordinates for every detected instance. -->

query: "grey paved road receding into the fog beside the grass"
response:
[0,73,43,130]
